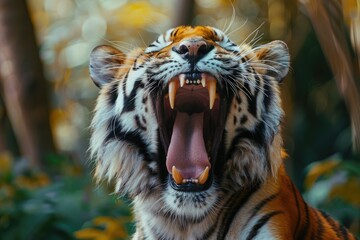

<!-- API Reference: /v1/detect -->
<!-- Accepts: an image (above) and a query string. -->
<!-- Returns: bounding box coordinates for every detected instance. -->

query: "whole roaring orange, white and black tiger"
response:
[89,26,355,240]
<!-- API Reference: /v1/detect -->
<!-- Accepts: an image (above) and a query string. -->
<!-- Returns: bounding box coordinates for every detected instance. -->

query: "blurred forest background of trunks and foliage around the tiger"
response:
[0,0,360,240]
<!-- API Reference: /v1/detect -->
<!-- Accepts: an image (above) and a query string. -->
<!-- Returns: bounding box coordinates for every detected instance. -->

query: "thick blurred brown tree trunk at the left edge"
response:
[0,0,54,167]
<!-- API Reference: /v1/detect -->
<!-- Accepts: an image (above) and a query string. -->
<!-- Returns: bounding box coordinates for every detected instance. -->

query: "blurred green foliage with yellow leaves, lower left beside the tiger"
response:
[0,156,131,240]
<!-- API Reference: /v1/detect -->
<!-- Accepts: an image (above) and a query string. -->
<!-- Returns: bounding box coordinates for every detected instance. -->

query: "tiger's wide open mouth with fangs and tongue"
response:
[157,72,226,192]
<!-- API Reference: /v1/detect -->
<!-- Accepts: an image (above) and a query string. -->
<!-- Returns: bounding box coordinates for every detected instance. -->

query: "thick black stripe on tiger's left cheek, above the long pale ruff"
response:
[104,116,154,162]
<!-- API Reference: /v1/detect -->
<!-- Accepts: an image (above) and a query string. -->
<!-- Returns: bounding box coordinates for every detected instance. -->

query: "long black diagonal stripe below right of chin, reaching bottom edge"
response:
[216,184,260,240]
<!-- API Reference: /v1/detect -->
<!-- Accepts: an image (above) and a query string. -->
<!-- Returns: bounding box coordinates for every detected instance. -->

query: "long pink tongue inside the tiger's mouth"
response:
[166,112,210,178]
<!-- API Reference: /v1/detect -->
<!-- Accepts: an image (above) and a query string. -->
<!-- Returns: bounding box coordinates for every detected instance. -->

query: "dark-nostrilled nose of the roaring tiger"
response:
[175,39,214,60]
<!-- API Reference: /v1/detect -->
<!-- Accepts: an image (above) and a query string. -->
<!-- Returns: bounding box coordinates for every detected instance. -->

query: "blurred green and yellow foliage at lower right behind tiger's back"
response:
[304,156,360,236]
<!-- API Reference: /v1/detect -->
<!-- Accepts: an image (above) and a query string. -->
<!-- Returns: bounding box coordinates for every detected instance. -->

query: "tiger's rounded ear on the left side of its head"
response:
[89,45,126,88]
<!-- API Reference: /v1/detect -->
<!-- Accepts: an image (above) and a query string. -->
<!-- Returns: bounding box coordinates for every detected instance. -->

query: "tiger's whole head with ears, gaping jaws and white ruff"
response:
[90,26,289,218]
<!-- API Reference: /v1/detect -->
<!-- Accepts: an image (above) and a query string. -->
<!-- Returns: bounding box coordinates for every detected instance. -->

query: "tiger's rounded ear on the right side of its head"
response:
[255,40,290,82]
